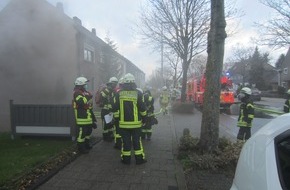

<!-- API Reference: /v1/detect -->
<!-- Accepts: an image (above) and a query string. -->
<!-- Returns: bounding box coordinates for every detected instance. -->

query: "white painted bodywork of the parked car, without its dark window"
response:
[231,114,290,190]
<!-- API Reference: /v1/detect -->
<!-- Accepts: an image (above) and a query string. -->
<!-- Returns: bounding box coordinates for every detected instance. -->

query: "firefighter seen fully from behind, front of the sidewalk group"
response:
[113,73,147,165]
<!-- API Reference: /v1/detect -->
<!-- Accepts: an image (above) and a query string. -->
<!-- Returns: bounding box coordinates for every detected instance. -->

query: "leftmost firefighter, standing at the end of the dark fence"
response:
[73,77,97,154]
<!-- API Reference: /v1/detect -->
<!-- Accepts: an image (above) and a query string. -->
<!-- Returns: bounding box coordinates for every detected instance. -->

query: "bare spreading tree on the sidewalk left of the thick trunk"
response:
[141,0,210,101]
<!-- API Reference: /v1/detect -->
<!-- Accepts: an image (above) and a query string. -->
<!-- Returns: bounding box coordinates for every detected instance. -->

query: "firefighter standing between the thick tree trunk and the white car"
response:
[237,87,254,141]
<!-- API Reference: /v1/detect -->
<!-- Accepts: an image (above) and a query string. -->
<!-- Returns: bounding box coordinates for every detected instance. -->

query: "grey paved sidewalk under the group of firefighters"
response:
[38,111,186,190]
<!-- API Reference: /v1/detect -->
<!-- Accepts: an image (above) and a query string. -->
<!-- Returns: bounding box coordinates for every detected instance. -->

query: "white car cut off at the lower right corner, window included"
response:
[231,113,290,190]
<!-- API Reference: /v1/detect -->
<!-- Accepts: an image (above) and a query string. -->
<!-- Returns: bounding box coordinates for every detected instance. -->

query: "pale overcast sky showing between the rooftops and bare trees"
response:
[0,0,287,76]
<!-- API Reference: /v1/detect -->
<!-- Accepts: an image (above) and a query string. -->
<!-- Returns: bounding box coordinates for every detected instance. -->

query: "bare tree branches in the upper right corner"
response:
[255,0,290,48]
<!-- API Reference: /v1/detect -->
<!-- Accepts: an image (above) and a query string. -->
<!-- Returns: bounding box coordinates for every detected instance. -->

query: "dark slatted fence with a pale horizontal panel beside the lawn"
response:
[10,100,76,140]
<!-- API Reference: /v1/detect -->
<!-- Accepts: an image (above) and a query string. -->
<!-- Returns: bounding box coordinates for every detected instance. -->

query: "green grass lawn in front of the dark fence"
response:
[0,133,73,189]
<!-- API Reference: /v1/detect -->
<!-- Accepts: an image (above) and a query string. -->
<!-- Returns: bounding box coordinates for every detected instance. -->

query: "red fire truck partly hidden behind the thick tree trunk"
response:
[186,75,235,109]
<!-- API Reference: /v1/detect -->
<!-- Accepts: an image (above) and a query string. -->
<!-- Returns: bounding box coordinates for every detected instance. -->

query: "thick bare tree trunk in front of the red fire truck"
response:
[199,0,226,153]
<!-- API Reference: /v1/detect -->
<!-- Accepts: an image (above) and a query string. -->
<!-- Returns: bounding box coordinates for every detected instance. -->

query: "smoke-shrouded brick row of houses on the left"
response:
[0,0,145,131]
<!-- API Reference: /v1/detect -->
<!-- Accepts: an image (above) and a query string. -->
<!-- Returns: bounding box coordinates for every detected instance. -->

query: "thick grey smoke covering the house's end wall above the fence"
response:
[0,0,78,130]
